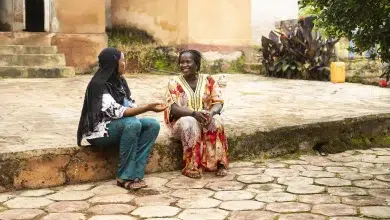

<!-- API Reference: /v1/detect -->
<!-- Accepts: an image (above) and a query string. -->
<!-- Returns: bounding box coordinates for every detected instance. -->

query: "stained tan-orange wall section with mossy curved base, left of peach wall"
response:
[111,0,188,44]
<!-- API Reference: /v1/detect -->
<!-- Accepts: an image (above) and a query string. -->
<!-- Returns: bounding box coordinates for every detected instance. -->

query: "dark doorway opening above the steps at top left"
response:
[25,0,45,32]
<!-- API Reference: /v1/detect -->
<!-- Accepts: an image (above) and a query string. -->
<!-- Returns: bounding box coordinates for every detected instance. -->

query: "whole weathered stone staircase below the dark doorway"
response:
[0,45,75,78]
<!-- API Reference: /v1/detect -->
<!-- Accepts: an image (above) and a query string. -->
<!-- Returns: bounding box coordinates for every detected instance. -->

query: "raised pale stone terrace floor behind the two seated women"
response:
[0,74,390,153]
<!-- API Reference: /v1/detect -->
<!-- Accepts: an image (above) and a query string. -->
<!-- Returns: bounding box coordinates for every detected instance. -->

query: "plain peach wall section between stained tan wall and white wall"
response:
[188,0,252,46]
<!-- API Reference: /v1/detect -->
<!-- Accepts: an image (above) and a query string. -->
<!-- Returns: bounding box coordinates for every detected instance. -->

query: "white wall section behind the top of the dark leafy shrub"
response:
[251,0,299,45]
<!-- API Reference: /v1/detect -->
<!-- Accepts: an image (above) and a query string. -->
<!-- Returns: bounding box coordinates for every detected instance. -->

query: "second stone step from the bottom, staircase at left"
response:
[0,54,66,67]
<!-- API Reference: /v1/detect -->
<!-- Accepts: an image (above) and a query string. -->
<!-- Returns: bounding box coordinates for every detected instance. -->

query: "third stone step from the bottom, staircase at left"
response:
[0,45,57,54]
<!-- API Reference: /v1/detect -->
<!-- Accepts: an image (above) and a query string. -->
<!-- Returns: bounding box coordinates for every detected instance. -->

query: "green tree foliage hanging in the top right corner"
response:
[299,0,390,62]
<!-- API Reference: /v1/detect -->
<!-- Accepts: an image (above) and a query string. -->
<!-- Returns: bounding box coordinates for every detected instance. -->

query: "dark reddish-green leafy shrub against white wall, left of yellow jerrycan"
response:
[262,17,338,80]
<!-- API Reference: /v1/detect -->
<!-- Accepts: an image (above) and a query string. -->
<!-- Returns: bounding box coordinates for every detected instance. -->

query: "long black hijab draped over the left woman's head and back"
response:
[77,48,131,146]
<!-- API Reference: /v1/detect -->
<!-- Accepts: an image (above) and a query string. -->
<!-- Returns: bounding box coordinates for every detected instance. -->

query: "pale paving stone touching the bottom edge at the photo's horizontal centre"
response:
[179,209,229,220]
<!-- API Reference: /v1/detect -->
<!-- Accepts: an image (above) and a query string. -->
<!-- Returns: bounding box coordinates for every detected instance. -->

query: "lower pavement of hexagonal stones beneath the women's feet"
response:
[0,148,390,220]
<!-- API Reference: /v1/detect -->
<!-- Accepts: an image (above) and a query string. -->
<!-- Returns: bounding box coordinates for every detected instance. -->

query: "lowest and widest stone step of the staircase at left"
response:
[0,66,75,78]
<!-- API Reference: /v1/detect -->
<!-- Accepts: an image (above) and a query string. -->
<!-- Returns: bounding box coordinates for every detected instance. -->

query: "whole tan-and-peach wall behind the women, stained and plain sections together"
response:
[111,0,252,46]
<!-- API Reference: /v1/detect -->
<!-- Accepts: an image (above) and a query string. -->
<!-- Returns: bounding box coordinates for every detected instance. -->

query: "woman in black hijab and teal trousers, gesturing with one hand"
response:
[77,48,166,190]
